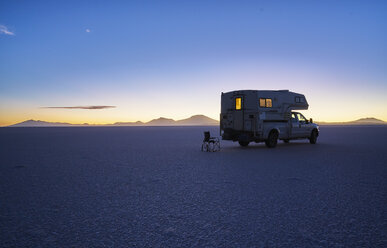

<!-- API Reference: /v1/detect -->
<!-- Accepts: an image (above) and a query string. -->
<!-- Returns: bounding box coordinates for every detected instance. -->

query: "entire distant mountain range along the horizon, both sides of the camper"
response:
[9,115,387,127]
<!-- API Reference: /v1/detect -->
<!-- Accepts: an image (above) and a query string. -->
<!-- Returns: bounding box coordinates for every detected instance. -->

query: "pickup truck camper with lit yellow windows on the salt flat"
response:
[220,90,319,147]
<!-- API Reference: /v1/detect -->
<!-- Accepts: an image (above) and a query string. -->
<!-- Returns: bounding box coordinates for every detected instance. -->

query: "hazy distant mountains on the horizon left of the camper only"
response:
[9,115,219,127]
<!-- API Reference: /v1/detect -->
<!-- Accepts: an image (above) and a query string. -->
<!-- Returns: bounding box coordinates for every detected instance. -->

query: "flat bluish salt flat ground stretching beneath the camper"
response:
[0,127,387,247]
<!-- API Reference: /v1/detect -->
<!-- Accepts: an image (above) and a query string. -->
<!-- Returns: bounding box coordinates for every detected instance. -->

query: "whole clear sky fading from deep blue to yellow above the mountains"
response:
[0,0,387,125]
